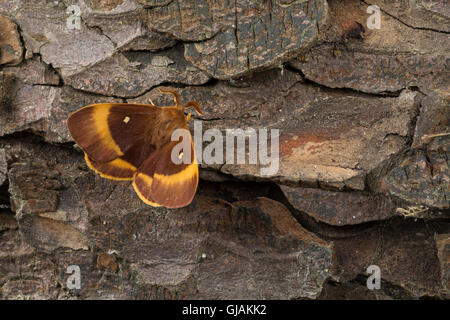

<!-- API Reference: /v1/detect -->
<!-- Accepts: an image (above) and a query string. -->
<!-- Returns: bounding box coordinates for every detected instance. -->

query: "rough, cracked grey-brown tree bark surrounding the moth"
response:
[0,0,450,299]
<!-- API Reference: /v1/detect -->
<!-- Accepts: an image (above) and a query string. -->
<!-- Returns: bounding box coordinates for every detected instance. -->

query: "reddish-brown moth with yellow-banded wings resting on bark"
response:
[67,89,203,208]
